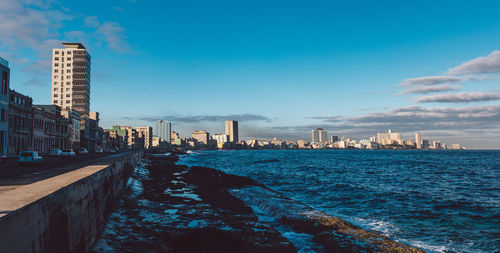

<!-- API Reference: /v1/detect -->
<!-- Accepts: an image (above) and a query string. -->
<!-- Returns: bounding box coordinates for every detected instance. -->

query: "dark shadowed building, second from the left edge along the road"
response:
[7,90,33,155]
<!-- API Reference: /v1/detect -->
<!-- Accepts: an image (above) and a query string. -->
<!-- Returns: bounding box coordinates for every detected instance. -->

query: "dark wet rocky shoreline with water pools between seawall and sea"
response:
[94,155,423,252]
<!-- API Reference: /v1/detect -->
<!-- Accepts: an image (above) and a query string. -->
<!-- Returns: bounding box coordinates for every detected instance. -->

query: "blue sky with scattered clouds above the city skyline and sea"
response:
[0,0,500,148]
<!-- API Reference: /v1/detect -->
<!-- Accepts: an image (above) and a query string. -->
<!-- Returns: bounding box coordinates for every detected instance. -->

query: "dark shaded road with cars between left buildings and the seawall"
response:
[0,153,131,190]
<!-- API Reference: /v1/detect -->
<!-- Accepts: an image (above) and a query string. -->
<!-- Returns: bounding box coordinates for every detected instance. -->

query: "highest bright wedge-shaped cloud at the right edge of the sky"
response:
[448,50,500,75]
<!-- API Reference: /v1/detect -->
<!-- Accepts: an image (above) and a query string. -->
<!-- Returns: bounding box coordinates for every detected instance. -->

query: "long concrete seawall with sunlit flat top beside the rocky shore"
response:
[0,152,143,252]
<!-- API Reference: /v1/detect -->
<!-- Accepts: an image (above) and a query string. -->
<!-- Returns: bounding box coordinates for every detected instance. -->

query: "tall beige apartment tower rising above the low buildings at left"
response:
[51,42,91,119]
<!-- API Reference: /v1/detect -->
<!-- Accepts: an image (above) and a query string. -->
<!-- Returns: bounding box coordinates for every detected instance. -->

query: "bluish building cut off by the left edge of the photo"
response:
[0,57,10,155]
